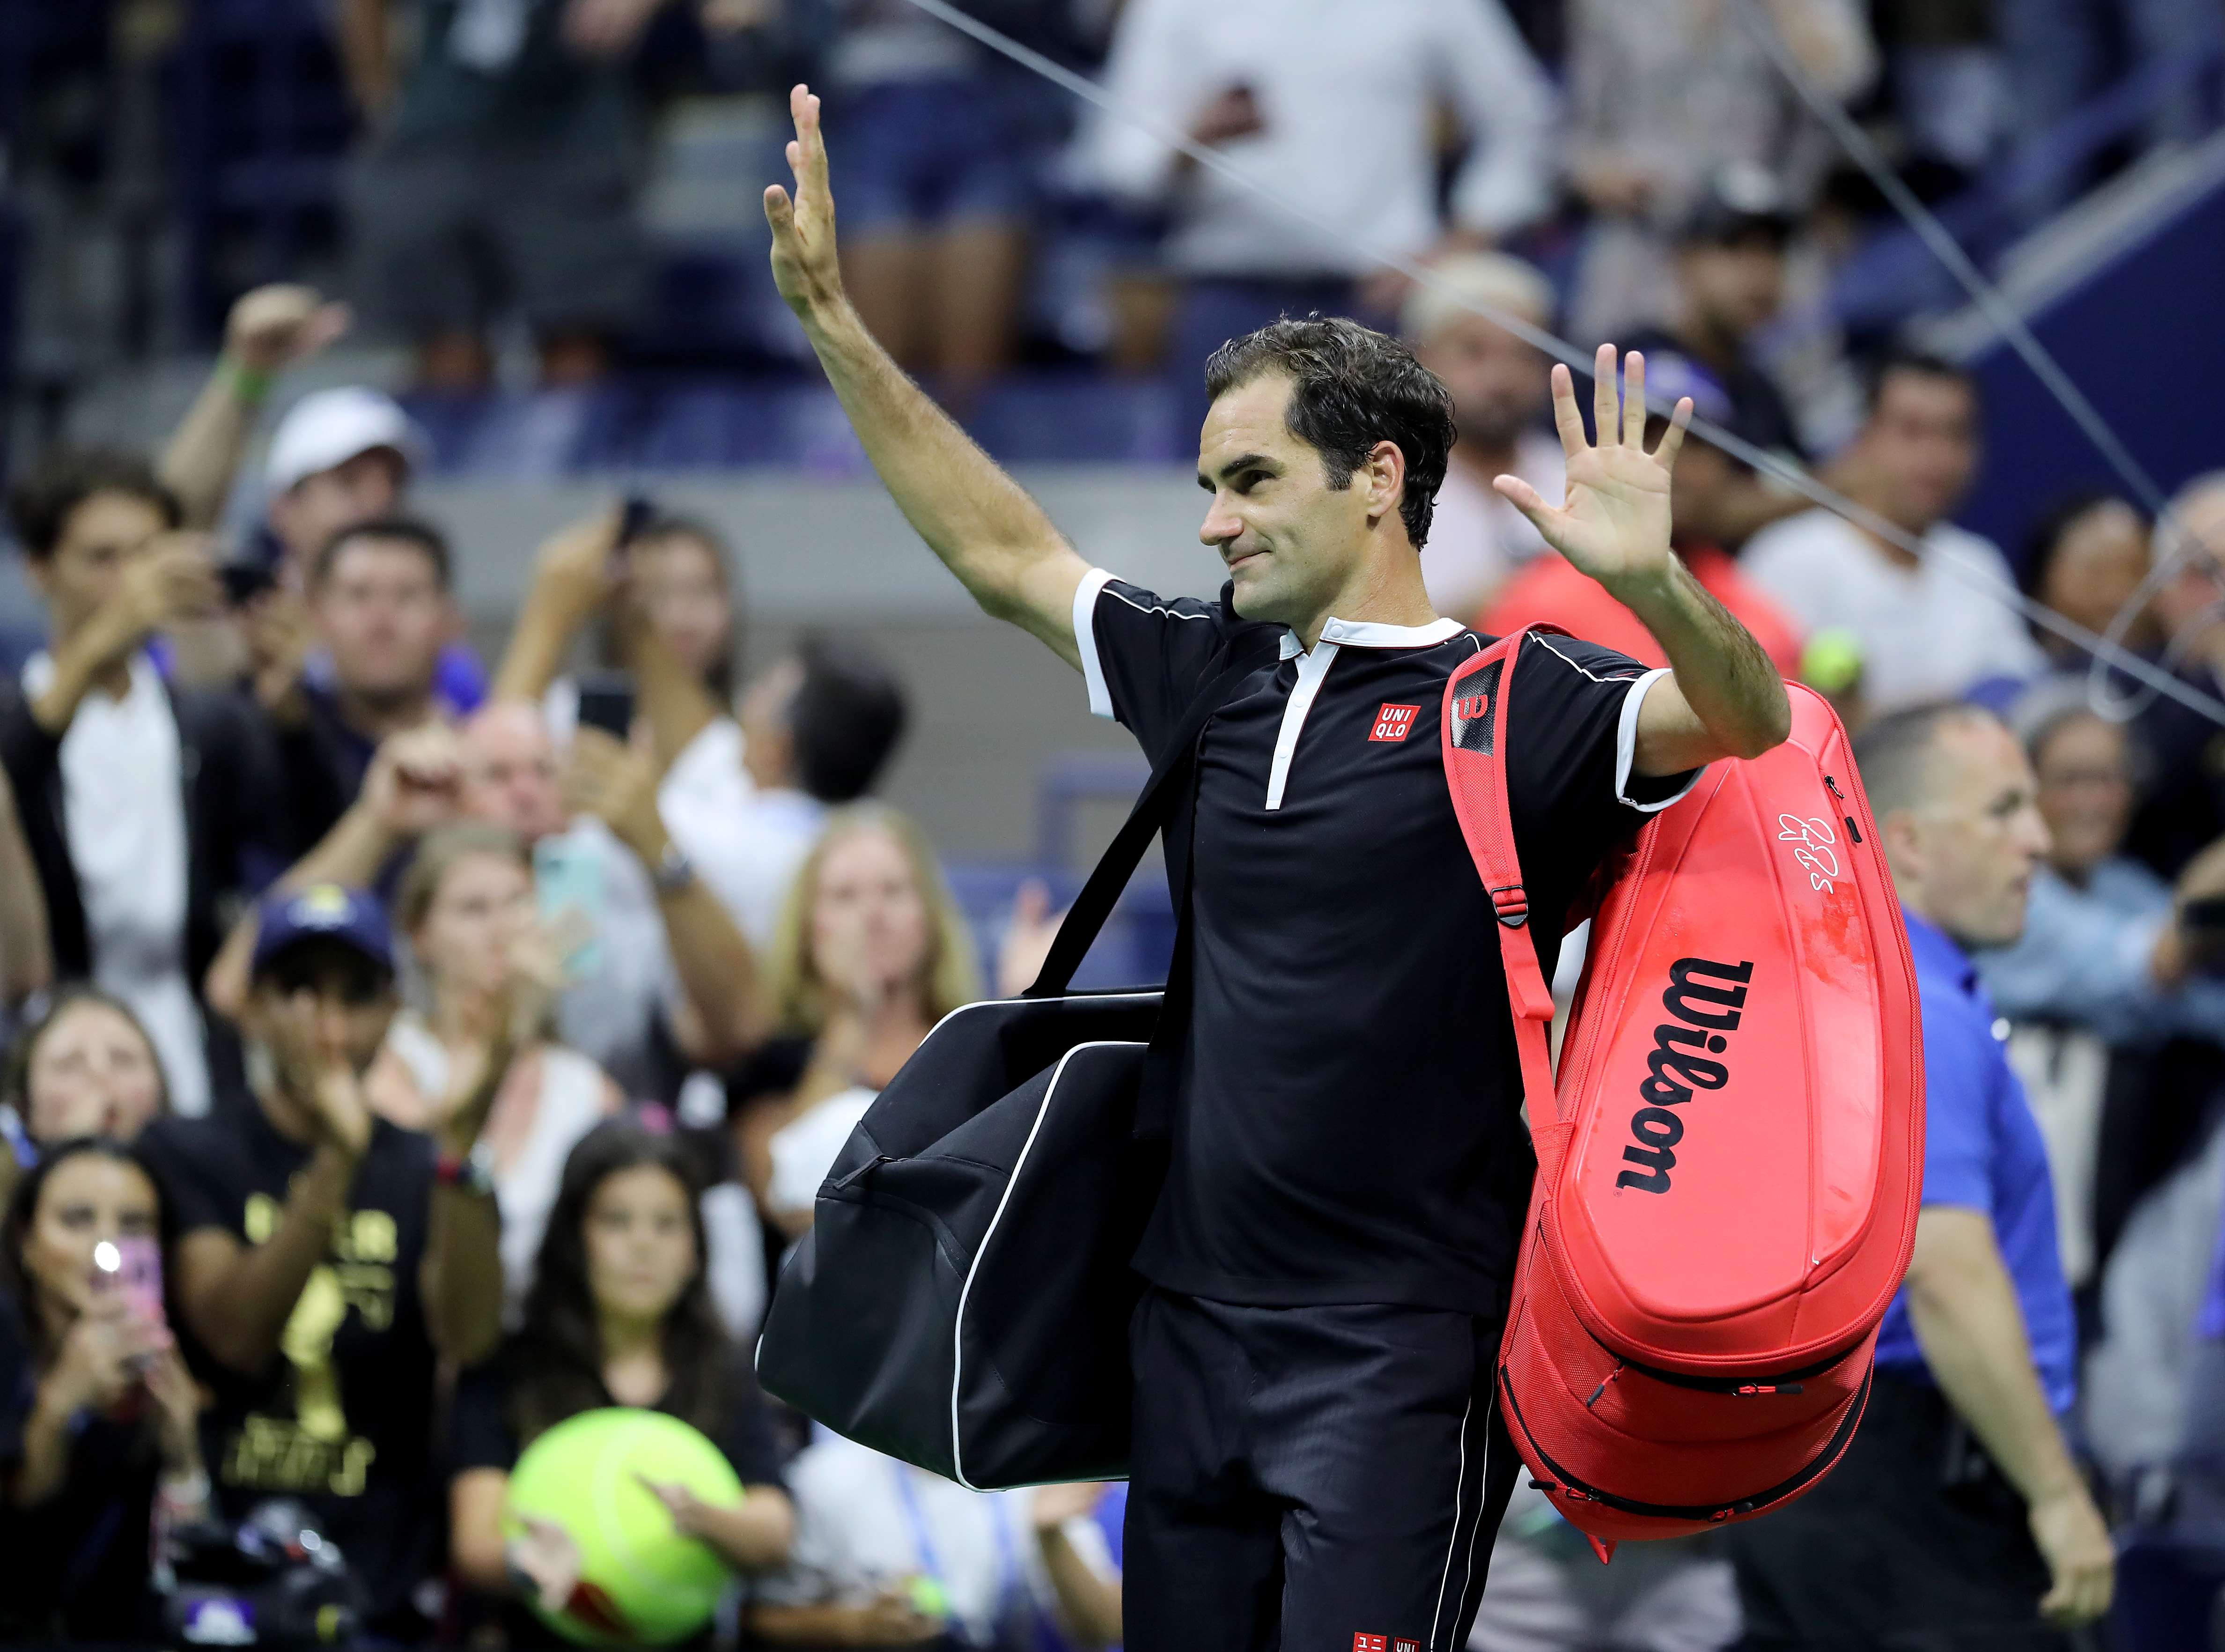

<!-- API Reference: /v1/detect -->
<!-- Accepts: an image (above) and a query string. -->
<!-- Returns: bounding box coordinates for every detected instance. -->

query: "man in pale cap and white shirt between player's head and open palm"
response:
[1400,251,1566,619]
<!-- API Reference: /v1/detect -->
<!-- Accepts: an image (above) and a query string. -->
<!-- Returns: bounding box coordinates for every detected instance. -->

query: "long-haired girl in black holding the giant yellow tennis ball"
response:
[449,1120,794,1645]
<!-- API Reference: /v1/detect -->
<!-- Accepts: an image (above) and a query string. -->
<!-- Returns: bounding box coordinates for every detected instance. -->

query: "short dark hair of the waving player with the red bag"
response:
[1206,316,1453,550]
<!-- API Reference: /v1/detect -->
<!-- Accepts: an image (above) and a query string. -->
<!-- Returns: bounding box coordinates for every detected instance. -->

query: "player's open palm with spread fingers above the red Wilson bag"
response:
[1491,345,1691,595]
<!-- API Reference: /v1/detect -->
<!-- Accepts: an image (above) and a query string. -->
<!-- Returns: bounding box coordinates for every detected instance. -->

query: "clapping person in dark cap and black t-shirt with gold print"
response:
[140,884,512,1641]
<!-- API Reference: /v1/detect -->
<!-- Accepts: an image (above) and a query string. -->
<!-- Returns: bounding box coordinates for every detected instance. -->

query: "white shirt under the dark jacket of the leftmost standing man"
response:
[22,652,209,1118]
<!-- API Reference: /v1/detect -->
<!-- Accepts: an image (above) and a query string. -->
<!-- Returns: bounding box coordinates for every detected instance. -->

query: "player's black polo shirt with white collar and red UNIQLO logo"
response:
[1075,572,1693,1313]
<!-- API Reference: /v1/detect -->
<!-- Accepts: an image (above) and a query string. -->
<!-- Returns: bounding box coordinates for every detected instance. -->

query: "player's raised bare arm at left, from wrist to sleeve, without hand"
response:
[805,301,1088,664]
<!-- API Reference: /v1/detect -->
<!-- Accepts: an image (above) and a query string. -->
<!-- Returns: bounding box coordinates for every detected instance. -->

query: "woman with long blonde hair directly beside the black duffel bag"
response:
[734,804,981,1238]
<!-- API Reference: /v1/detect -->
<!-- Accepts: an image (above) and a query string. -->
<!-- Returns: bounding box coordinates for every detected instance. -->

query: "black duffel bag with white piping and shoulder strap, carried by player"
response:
[757,626,1273,1492]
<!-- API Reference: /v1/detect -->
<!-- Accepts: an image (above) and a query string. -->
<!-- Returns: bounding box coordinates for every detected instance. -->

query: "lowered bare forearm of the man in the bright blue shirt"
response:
[1909,1220,2080,1503]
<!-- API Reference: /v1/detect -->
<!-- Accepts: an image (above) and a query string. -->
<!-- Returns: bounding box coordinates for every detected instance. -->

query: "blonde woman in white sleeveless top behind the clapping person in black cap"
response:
[367,821,625,1318]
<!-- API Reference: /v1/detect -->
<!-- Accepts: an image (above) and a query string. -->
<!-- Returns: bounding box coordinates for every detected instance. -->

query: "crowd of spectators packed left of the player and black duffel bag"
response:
[0,292,1148,1647]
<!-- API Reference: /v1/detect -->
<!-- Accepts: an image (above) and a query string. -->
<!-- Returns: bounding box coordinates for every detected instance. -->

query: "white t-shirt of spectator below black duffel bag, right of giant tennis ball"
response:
[752,1431,1112,1652]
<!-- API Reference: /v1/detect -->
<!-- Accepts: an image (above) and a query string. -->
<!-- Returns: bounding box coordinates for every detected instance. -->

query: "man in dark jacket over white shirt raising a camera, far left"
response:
[0,452,296,1115]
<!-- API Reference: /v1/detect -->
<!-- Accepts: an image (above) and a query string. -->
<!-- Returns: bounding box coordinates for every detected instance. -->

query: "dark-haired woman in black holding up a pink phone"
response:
[0,1136,209,1641]
